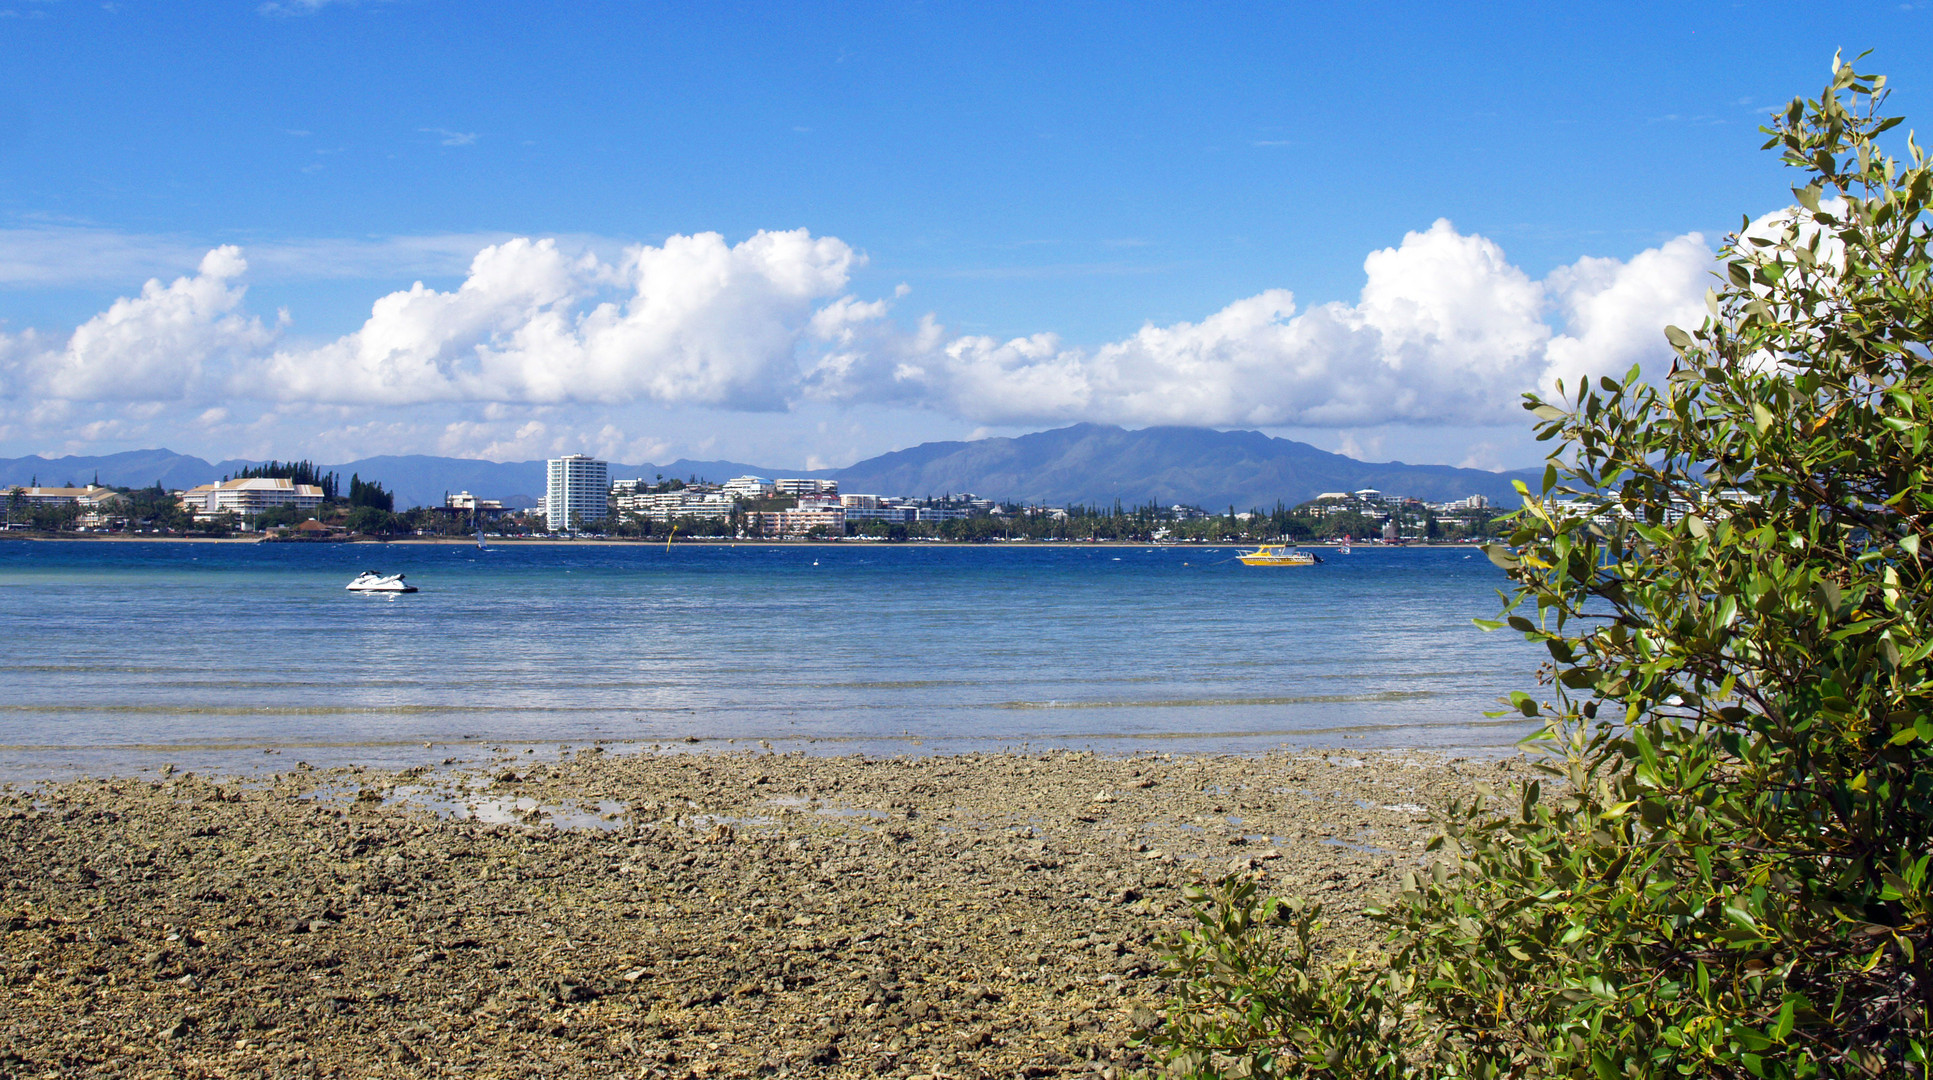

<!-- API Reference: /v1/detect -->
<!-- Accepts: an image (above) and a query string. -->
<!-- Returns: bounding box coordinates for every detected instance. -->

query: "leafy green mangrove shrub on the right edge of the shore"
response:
[1150,60,1933,1078]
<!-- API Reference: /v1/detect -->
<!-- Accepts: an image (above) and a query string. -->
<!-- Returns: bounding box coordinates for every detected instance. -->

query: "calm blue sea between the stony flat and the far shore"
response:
[0,541,1537,779]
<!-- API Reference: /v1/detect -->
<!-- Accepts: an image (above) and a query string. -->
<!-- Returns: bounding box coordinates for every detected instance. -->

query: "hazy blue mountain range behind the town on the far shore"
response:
[0,423,1539,510]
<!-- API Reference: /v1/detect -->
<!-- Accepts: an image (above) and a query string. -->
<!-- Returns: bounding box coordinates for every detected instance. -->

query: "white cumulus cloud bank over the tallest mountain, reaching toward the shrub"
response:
[812,220,1713,427]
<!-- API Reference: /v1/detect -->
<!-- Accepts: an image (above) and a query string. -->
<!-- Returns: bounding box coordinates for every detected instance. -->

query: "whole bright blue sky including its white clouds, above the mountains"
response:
[0,0,1933,468]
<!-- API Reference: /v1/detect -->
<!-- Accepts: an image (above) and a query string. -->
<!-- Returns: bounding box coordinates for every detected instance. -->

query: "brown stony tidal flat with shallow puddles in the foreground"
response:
[0,746,1527,1076]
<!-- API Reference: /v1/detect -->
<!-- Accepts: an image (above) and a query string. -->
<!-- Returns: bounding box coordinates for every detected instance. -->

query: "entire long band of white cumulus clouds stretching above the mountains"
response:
[0,220,1715,456]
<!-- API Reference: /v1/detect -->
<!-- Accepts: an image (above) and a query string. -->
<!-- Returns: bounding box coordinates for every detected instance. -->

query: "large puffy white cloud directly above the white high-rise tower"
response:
[269,230,862,410]
